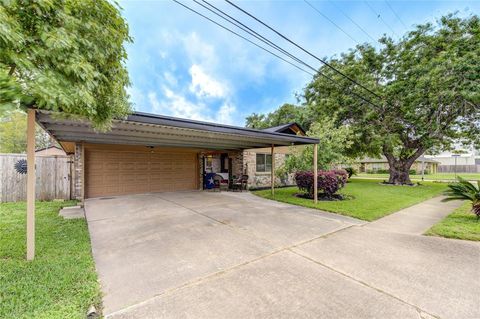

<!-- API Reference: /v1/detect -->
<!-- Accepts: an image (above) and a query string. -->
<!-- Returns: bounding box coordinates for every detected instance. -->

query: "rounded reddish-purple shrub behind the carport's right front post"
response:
[295,169,348,197]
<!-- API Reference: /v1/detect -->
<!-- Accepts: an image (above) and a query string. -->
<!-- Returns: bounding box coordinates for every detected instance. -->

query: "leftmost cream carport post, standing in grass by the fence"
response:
[27,109,35,260]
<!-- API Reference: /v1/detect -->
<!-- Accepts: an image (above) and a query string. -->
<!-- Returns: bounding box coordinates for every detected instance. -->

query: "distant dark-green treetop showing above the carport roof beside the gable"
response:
[246,103,311,130]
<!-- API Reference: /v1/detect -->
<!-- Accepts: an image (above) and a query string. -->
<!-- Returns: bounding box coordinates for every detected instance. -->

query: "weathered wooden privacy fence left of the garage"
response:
[0,154,73,202]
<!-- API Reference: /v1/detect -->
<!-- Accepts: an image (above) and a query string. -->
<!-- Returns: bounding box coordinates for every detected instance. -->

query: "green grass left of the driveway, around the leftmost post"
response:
[0,202,101,318]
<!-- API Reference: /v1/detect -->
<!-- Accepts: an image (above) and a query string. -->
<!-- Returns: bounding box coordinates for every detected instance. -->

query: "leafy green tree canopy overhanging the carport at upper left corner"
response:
[0,0,131,128]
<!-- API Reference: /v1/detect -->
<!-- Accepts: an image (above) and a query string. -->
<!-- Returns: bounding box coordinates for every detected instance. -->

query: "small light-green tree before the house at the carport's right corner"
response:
[279,118,351,173]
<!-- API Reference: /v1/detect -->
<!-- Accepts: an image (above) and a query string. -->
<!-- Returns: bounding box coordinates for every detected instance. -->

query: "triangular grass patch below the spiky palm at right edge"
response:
[425,202,480,241]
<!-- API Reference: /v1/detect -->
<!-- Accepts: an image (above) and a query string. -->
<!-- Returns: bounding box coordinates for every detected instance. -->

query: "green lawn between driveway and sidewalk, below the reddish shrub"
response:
[253,179,446,221]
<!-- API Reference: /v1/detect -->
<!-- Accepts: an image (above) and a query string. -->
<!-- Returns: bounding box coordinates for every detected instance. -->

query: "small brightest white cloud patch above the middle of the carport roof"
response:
[188,64,228,98]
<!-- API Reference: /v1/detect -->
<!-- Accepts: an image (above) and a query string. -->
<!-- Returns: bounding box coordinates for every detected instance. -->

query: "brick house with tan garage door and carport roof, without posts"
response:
[36,110,319,199]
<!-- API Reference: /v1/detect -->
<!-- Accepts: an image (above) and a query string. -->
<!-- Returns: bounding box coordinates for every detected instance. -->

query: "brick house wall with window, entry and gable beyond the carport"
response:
[200,123,306,188]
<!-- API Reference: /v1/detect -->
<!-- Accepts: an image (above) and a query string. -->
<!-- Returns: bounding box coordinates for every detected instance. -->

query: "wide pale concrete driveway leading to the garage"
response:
[85,192,480,318]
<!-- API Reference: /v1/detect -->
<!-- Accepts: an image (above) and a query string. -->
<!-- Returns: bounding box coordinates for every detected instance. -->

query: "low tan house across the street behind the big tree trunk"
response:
[353,156,439,174]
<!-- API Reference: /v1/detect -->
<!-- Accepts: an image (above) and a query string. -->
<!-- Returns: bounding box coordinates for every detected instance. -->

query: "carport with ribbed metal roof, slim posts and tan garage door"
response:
[27,109,319,260]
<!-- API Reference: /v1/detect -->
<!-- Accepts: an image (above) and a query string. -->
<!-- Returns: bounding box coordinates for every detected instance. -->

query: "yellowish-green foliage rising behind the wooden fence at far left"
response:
[0,111,56,153]
